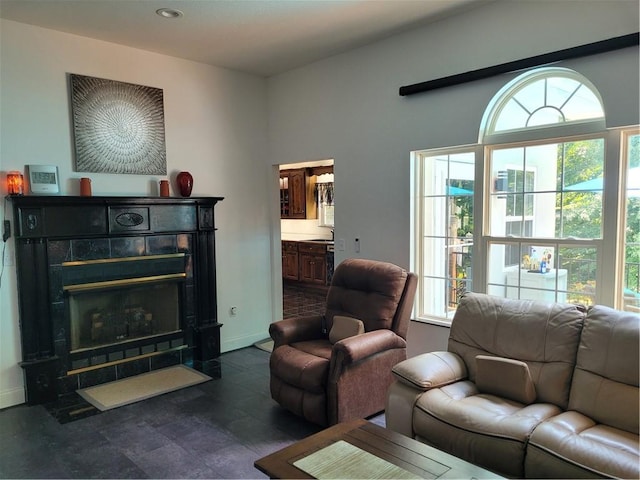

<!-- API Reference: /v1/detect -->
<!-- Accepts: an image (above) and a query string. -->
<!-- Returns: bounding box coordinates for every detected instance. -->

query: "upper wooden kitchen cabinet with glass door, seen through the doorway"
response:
[280,168,317,219]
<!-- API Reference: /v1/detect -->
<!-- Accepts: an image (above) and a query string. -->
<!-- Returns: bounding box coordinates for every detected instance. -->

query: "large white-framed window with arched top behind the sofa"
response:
[412,68,640,323]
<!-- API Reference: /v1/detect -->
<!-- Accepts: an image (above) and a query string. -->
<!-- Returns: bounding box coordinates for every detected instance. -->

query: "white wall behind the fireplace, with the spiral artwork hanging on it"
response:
[0,20,281,408]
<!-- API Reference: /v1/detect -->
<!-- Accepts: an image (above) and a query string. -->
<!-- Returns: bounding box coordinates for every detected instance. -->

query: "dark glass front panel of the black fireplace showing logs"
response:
[69,282,180,352]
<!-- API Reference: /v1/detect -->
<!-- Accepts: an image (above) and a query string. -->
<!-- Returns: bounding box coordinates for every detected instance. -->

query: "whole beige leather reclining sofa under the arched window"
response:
[386,293,640,478]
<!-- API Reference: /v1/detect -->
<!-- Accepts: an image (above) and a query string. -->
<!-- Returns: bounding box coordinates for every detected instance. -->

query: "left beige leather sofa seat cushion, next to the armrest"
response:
[413,381,560,478]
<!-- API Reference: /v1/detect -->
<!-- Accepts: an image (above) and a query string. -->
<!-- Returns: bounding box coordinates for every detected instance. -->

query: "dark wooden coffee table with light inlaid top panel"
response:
[254,419,502,478]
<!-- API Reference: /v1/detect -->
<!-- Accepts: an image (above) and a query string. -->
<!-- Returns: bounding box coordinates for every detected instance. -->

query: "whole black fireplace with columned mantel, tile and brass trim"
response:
[8,196,222,405]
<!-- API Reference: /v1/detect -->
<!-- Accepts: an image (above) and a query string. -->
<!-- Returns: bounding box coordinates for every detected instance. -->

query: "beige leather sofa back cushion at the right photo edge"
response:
[569,305,640,435]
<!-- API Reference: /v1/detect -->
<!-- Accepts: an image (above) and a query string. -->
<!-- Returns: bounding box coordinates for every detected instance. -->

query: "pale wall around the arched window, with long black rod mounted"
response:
[266,0,639,354]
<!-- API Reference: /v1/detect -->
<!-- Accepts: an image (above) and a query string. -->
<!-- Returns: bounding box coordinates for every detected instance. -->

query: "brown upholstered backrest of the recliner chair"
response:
[325,258,417,339]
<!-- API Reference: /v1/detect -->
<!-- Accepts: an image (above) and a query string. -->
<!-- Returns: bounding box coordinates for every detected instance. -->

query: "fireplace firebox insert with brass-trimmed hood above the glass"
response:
[62,253,187,358]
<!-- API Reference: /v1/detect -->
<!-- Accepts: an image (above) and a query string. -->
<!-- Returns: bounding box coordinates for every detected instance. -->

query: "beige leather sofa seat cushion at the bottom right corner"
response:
[525,411,640,478]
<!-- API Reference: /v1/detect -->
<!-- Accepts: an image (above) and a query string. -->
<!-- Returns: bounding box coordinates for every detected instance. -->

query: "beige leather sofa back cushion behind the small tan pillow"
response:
[448,293,585,408]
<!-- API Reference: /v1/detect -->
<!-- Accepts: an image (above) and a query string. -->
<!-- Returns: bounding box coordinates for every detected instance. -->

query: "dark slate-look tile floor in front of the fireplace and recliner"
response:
[0,347,384,478]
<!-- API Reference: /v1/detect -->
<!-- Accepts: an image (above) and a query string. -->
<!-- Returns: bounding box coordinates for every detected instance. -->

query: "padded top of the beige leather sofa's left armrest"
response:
[391,352,467,391]
